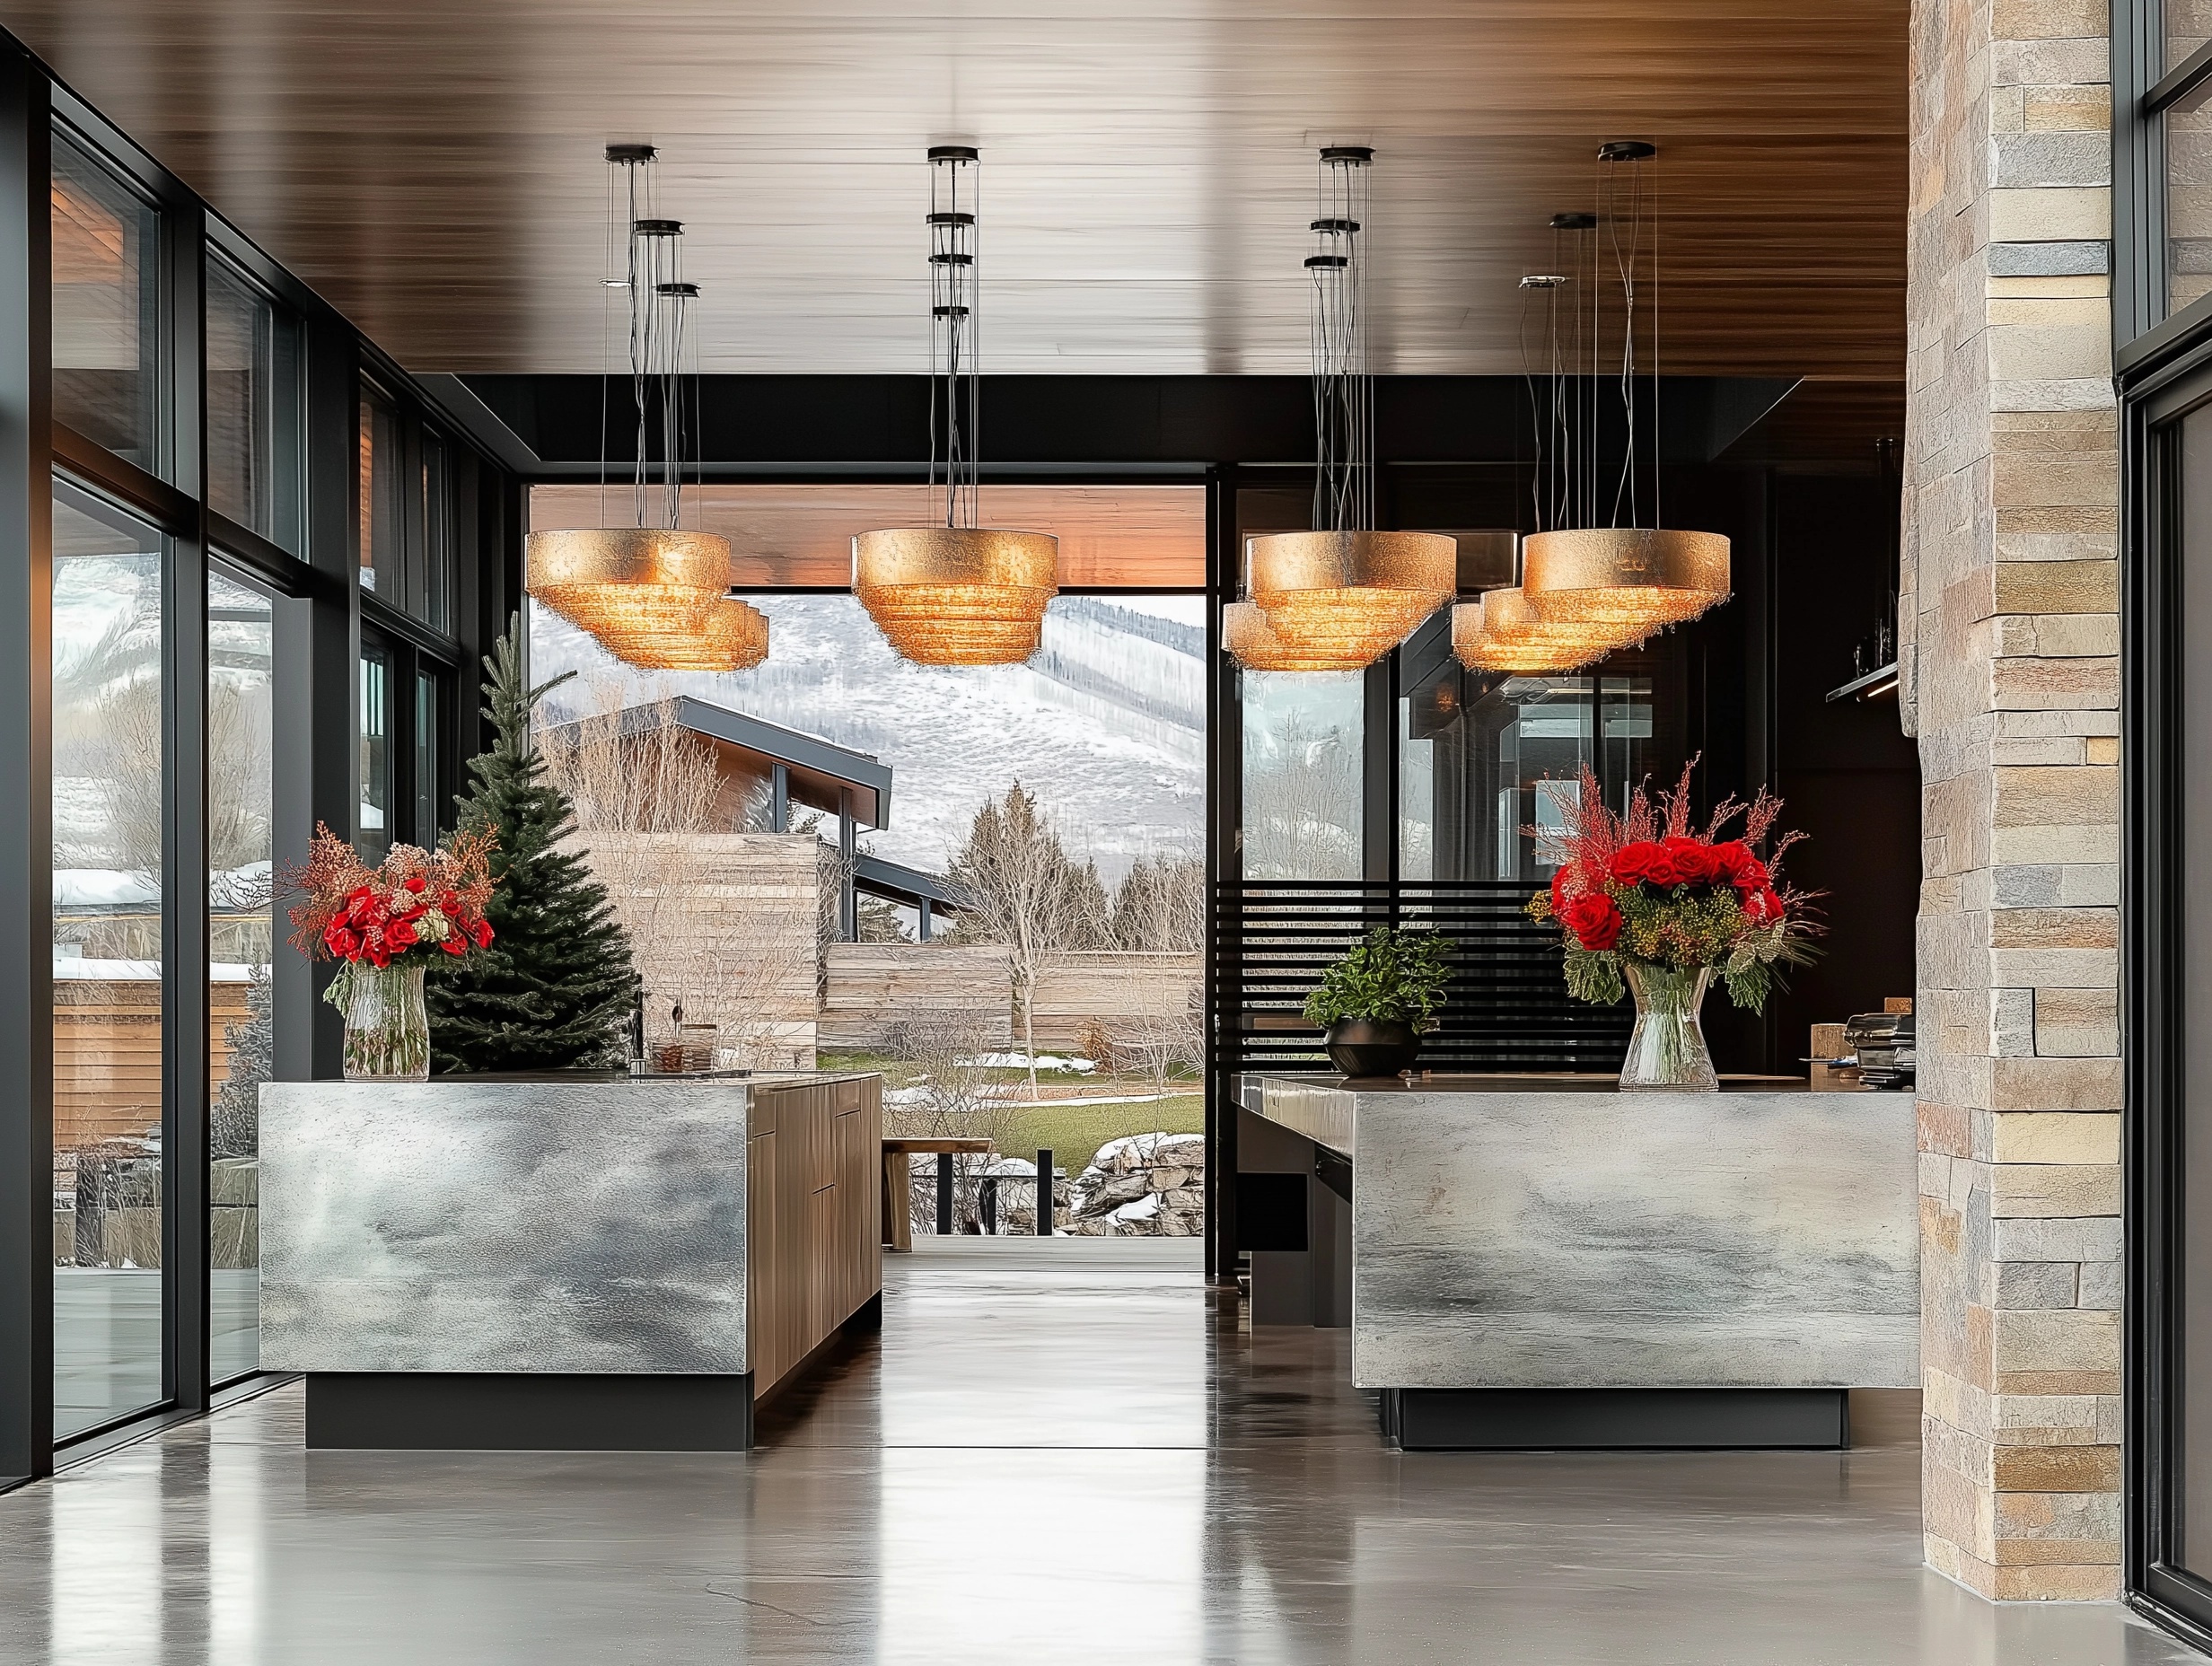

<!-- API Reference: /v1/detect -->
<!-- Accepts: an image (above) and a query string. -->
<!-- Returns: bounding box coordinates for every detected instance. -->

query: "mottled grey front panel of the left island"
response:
[261,1080,750,1374]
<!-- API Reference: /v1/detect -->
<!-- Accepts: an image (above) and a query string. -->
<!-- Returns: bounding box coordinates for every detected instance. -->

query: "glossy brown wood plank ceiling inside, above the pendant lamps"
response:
[0,0,1907,378]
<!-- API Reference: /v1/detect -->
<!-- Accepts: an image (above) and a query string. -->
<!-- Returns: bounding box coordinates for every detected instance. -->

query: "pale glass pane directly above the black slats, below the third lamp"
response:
[1239,671,1367,879]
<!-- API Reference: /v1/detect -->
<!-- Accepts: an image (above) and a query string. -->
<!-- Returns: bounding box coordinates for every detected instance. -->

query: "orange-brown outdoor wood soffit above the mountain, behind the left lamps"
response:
[531,482,1206,591]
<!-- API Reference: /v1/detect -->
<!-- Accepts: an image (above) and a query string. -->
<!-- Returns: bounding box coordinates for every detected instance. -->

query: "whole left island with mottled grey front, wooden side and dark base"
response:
[261,1073,882,1449]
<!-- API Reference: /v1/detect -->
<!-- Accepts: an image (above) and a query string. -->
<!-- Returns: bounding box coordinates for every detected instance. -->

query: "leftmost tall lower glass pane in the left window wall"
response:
[53,487,163,1441]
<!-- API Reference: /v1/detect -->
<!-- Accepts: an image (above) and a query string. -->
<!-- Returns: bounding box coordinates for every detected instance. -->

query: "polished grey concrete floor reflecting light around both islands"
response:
[0,1239,2199,1666]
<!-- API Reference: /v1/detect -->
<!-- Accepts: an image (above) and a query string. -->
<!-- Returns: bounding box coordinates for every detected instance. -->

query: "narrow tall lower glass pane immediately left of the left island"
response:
[208,571,276,1383]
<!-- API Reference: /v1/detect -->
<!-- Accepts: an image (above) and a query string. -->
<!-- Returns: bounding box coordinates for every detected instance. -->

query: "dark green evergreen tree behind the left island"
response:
[425,615,637,1073]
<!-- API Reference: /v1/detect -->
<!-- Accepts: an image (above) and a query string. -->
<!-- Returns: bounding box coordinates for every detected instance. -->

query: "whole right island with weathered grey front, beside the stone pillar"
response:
[1236,1075,1920,1445]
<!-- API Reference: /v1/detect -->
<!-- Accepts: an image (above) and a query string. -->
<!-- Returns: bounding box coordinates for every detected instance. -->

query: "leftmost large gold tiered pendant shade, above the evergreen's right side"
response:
[522,527,730,637]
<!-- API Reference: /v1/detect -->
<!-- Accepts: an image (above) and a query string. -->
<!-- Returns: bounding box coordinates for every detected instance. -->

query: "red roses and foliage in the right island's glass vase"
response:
[1529,758,1818,1013]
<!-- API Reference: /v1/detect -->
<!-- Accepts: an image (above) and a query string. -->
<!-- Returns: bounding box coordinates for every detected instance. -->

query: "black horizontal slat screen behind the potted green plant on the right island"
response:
[1212,881,1635,1073]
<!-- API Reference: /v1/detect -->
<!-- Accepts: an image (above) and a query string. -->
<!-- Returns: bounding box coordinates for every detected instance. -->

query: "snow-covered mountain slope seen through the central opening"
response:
[531,595,1206,885]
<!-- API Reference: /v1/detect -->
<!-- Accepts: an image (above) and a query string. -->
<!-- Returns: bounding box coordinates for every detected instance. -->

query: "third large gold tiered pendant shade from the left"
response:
[1239,531,1460,666]
